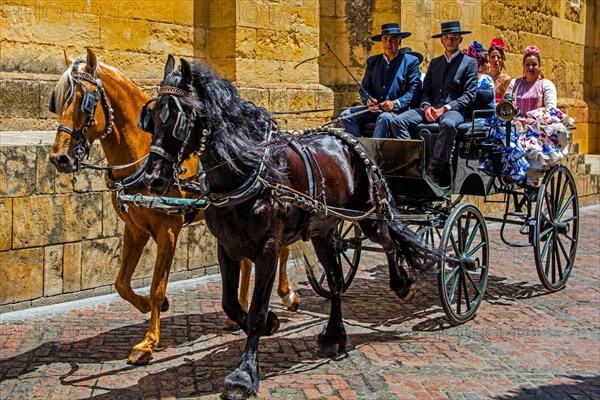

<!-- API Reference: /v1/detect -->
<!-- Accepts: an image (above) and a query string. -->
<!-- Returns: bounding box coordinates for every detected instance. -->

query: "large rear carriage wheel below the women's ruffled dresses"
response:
[533,165,579,292]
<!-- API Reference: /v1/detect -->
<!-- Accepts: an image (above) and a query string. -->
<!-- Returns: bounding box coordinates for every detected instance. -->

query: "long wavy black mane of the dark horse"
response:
[163,62,281,175]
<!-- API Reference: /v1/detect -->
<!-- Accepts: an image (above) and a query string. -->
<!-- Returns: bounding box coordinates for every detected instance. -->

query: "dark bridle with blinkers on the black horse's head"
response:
[138,86,209,182]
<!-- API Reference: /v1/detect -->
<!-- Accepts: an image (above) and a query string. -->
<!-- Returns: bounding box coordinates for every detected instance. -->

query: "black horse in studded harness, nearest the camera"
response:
[140,56,435,398]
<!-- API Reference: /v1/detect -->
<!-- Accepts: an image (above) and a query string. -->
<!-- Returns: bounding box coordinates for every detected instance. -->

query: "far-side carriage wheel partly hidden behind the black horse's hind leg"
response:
[304,221,364,299]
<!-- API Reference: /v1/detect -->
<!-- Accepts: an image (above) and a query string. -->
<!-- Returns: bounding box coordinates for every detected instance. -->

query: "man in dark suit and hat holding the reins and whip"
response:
[340,23,421,138]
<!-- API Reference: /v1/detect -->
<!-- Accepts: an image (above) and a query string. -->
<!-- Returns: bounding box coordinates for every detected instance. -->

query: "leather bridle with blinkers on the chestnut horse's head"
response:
[48,58,115,170]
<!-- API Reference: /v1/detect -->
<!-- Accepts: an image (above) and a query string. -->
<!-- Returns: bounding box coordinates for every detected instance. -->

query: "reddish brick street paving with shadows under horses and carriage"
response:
[0,205,600,400]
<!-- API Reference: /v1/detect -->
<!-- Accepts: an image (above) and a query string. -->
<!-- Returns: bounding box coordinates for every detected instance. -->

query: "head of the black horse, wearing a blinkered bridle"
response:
[143,55,204,194]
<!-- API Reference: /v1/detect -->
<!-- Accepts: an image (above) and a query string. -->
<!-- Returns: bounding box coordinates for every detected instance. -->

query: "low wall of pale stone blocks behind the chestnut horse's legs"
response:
[0,138,218,313]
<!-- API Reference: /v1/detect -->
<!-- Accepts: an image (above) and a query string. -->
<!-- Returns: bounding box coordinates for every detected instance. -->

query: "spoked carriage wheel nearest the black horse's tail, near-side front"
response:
[438,203,490,324]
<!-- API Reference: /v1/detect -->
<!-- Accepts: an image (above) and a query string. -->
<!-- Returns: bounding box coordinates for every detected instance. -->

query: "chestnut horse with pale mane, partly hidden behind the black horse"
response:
[50,49,298,365]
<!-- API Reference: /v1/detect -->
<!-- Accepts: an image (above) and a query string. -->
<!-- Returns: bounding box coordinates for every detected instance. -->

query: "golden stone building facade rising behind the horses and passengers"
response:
[0,0,600,153]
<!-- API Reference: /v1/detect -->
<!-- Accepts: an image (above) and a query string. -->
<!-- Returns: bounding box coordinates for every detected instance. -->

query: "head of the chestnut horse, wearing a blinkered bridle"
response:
[49,49,113,173]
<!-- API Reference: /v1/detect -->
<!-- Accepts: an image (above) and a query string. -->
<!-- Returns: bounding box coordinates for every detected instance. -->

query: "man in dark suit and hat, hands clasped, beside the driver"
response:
[390,21,477,186]
